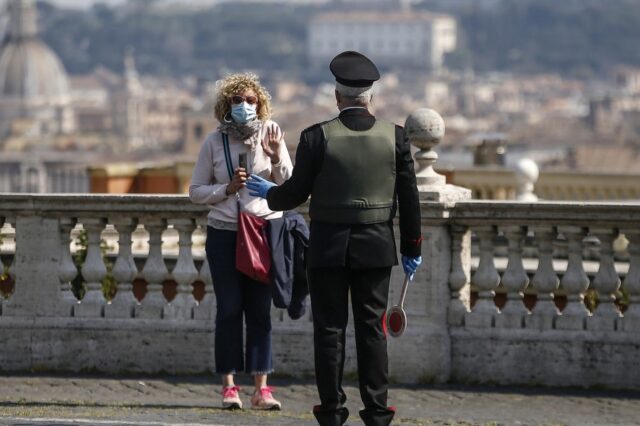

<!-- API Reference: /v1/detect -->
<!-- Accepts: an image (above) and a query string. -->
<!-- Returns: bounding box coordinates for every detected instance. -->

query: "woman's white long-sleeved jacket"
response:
[189,121,293,229]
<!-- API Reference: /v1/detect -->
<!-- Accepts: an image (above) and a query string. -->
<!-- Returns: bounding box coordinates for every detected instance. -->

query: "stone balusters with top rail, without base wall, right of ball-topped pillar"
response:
[448,201,640,332]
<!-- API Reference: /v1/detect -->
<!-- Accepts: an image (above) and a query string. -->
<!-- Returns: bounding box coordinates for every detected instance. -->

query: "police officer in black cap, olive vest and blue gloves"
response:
[247,51,422,426]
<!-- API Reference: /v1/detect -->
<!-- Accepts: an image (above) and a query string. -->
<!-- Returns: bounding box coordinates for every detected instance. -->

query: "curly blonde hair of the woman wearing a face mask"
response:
[215,73,271,123]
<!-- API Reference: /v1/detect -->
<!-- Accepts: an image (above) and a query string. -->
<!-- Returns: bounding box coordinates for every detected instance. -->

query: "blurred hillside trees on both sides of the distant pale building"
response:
[40,0,640,78]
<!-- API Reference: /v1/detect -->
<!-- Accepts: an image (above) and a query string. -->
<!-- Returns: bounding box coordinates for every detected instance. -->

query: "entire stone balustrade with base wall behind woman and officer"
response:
[0,194,640,388]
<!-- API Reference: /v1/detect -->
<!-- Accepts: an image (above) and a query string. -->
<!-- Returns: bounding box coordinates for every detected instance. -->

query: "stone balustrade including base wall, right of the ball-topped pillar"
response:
[448,201,640,388]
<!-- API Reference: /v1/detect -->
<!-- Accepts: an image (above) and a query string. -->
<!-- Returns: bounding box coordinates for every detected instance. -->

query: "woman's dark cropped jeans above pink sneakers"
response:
[206,226,272,374]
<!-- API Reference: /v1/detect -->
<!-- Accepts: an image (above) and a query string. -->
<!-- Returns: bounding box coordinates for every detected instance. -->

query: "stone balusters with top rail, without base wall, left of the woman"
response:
[0,195,213,320]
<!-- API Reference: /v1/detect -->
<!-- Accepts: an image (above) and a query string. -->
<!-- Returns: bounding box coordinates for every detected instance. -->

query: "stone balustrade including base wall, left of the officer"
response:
[0,194,312,373]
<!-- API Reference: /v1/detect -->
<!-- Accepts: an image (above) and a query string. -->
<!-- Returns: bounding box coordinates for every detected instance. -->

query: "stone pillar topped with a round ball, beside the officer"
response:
[389,109,471,383]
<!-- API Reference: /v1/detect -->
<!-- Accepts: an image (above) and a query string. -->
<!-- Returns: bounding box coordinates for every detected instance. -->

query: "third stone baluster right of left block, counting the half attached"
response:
[104,217,138,318]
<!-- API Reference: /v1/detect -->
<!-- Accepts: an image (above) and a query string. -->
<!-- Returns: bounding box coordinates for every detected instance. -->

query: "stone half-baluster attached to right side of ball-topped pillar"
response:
[448,225,471,326]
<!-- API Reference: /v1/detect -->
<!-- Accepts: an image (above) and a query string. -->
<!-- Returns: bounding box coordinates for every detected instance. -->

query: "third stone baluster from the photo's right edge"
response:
[556,226,590,330]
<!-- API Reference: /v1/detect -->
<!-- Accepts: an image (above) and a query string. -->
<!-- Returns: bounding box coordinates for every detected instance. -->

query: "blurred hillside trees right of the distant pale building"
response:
[436,0,640,77]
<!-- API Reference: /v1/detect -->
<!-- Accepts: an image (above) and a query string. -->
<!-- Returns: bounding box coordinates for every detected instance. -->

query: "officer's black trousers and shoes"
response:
[309,267,394,426]
